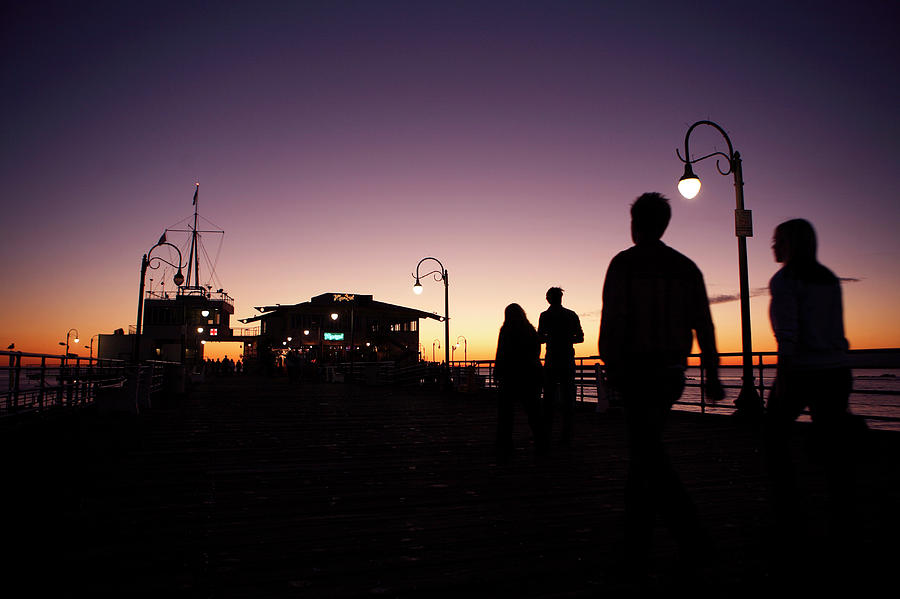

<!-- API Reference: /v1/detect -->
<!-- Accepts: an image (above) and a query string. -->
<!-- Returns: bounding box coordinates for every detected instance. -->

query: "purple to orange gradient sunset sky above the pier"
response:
[0,0,900,359]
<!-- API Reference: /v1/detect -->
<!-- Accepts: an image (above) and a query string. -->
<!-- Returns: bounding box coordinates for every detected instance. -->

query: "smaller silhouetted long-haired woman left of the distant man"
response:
[494,304,544,460]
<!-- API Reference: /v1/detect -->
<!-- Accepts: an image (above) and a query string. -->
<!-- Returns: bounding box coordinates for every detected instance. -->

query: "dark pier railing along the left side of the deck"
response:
[0,351,180,417]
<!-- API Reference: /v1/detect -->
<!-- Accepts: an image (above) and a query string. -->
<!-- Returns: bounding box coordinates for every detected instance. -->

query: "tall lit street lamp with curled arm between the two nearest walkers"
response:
[675,121,763,416]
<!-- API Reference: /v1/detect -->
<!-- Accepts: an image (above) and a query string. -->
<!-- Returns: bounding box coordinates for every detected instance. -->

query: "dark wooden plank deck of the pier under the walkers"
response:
[0,377,900,598]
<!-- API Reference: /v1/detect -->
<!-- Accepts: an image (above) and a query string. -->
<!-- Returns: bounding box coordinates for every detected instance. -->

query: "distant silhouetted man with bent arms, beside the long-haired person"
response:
[538,287,584,445]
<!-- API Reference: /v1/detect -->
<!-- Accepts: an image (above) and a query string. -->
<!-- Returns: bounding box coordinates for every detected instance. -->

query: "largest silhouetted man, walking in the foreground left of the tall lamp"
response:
[599,193,724,574]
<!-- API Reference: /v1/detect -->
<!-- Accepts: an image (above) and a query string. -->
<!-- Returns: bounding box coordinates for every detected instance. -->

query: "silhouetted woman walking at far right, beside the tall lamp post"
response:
[766,219,864,540]
